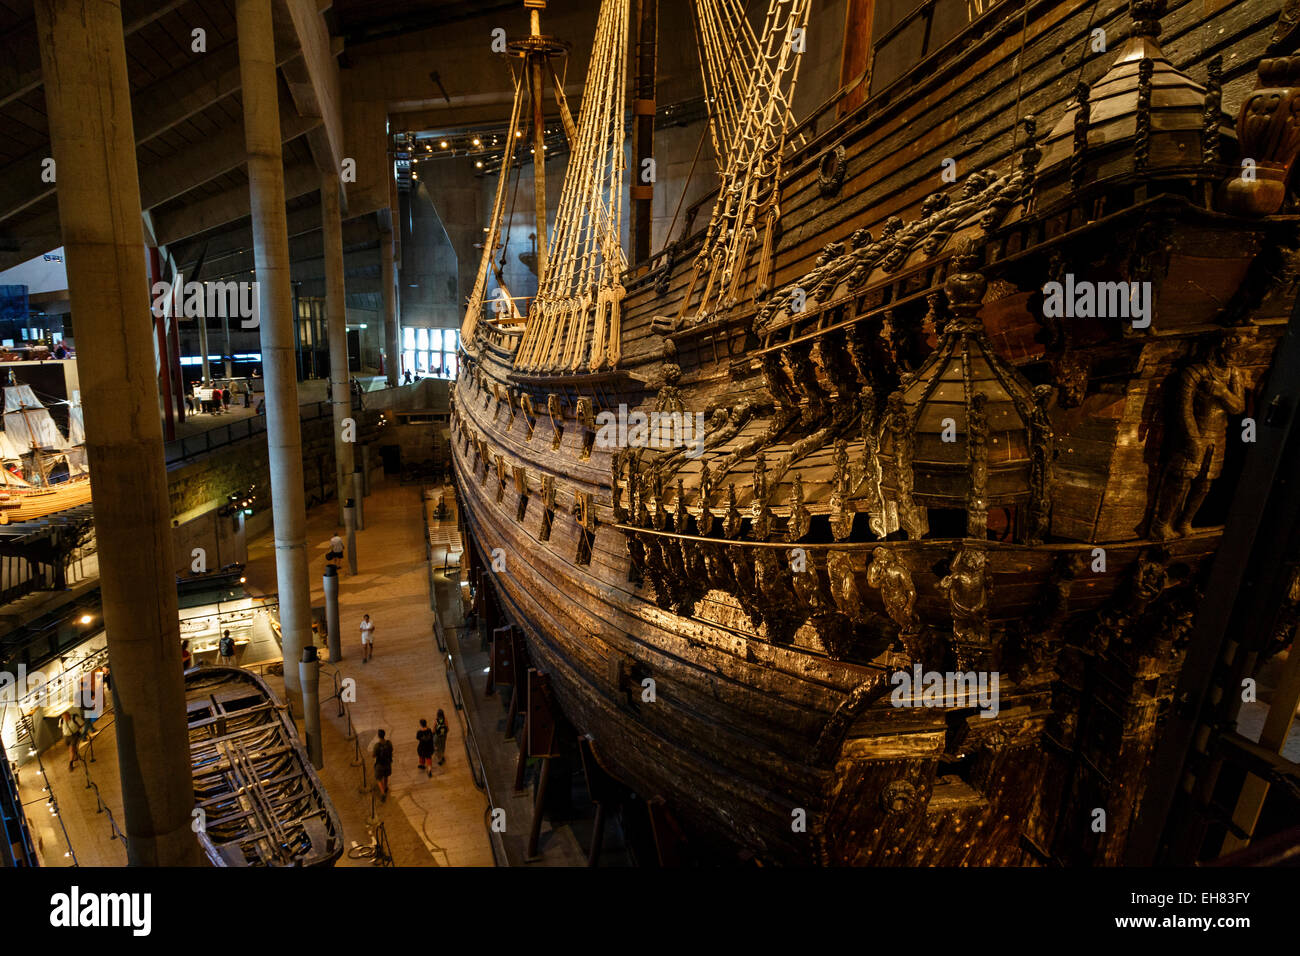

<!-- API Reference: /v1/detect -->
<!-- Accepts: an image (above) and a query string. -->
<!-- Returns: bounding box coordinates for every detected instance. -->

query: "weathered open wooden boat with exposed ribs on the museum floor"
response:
[185,667,343,866]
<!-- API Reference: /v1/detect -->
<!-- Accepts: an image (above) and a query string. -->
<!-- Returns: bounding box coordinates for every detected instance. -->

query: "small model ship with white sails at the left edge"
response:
[0,385,91,524]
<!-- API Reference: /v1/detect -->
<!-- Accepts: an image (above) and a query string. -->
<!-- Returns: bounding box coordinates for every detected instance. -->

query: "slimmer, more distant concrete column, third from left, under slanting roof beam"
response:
[321,173,356,522]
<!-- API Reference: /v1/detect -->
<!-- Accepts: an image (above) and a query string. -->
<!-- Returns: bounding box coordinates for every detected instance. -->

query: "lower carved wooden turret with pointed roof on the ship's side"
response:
[880,242,1034,540]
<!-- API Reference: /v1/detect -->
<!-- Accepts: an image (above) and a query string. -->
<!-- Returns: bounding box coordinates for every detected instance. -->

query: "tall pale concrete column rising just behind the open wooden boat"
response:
[235,0,312,714]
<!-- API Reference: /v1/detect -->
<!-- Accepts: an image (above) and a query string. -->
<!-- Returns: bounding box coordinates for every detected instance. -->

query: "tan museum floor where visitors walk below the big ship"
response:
[20,480,494,866]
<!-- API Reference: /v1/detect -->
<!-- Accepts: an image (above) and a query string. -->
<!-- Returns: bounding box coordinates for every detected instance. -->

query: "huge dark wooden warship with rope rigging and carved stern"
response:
[452,0,1300,865]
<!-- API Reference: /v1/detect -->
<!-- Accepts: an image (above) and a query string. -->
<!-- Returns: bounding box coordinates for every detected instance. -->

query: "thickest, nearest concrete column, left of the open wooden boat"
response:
[35,0,200,866]
